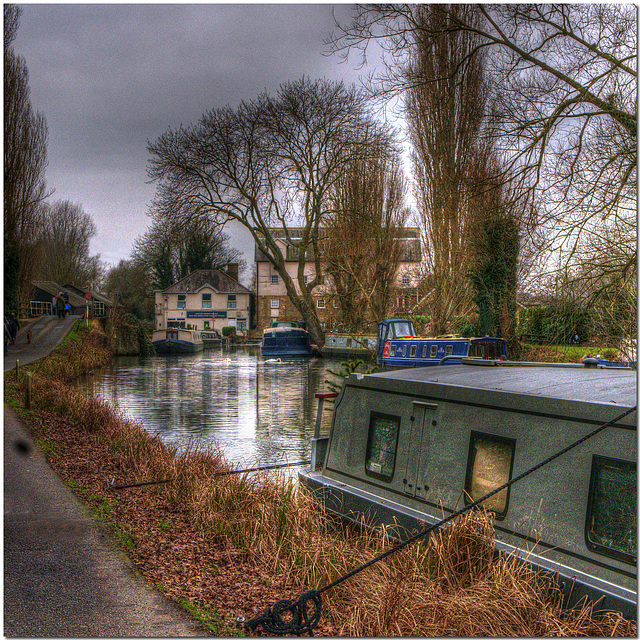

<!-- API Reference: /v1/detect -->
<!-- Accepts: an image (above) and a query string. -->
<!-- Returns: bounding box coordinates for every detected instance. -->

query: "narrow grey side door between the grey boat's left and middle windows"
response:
[402,400,438,500]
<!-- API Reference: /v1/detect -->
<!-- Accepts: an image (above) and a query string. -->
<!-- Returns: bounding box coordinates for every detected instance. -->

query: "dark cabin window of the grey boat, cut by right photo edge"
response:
[586,455,638,564]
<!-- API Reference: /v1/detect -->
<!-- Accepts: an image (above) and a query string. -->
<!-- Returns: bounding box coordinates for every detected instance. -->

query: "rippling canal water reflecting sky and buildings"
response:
[79,347,340,467]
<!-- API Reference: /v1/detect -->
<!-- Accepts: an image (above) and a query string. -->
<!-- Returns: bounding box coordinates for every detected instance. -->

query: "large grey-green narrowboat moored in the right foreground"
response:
[299,359,637,620]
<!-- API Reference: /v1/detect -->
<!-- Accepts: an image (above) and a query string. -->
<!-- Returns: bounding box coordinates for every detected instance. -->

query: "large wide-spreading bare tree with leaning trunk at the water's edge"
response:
[149,78,388,346]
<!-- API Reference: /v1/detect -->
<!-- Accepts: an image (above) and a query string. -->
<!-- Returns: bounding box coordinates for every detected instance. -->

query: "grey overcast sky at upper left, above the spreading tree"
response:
[13,3,380,282]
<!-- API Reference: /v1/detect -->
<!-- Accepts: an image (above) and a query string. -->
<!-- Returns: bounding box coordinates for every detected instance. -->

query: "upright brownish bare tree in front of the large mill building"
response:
[323,156,409,331]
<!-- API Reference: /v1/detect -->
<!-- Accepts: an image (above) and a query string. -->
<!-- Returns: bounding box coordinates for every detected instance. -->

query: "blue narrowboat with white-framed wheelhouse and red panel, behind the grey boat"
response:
[377,318,507,368]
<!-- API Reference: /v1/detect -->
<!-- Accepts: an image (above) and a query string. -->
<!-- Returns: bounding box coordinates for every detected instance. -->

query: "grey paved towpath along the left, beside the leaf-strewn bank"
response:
[4,319,210,638]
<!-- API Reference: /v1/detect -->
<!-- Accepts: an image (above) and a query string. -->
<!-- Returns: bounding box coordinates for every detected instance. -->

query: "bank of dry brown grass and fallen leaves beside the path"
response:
[5,326,637,637]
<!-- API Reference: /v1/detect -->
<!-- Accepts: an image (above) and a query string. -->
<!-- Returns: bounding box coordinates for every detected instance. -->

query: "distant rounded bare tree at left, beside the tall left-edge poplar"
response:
[38,200,104,288]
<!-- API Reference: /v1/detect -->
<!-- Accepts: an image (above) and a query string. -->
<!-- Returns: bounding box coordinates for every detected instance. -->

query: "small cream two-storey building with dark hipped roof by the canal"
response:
[155,265,251,333]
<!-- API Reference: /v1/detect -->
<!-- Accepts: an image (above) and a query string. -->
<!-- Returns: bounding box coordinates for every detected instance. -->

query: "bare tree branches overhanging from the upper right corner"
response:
[332,3,637,260]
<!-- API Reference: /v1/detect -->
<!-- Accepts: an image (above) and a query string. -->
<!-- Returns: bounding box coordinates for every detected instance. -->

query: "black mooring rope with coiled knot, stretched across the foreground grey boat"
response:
[244,406,637,636]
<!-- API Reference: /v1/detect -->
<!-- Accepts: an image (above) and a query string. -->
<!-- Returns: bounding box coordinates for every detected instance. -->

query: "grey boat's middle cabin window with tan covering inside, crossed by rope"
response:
[465,431,516,520]
